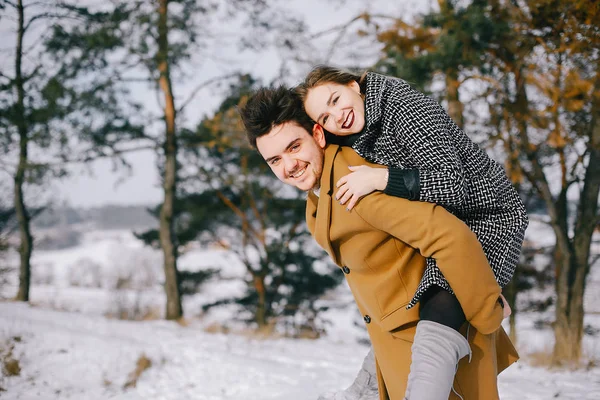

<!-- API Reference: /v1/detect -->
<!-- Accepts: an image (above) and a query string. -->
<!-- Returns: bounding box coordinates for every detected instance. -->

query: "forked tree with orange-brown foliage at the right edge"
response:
[472,0,600,365]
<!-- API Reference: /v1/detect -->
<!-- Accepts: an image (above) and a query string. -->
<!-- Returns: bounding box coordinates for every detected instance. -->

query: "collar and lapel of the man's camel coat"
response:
[306,144,341,265]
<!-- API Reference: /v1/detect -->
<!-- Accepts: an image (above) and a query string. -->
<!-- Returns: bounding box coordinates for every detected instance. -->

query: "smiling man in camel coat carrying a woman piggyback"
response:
[241,88,518,400]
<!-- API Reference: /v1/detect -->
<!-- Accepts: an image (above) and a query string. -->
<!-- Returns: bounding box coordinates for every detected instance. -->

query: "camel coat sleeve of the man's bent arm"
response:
[354,192,503,334]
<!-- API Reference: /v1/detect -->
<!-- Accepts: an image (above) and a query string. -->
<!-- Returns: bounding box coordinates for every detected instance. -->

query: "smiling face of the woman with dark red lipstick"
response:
[304,81,365,136]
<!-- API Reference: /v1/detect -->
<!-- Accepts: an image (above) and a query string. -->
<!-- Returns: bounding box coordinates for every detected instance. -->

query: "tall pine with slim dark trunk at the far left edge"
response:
[0,0,142,301]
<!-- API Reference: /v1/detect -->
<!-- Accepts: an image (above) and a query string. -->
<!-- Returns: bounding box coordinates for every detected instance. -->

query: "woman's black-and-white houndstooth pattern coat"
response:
[352,72,529,308]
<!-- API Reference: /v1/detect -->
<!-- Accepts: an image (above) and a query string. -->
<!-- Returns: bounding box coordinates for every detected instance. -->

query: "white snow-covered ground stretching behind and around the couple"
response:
[0,223,600,400]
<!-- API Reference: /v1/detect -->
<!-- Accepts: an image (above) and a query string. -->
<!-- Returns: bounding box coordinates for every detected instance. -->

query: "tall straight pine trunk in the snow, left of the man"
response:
[157,0,183,319]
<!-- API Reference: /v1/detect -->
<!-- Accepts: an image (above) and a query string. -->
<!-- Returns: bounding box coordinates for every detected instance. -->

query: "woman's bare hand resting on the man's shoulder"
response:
[335,165,388,211]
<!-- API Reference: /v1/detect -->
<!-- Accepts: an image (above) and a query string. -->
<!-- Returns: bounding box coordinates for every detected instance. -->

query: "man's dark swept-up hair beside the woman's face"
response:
[240,86,314,149]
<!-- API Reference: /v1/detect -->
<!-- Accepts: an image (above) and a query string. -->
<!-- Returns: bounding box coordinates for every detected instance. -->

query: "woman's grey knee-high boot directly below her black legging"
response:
[404,321,471,400]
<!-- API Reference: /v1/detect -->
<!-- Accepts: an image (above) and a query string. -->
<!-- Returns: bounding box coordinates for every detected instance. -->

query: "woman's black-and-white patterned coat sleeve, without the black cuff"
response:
[384,82,465,207]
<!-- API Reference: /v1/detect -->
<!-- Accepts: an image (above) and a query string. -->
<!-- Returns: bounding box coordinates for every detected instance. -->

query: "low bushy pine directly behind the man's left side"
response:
[137,76,341,331]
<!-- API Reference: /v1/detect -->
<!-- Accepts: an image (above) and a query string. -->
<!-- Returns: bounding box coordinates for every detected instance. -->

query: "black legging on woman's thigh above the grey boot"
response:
[419,286,466,331]
